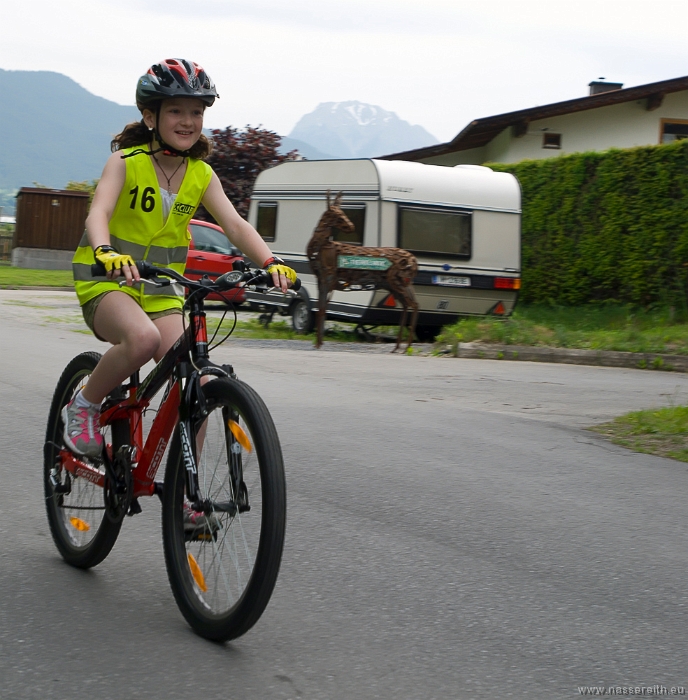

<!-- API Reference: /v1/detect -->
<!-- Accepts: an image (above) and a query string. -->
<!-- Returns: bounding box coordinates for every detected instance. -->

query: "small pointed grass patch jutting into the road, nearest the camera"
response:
[590,406,688,462]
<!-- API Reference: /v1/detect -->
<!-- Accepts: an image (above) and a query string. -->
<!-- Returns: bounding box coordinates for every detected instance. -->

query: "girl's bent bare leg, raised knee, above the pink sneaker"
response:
[82,292,163,404]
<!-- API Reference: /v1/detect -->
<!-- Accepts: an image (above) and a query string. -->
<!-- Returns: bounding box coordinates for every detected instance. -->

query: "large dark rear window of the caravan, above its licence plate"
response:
[399,205,472,258]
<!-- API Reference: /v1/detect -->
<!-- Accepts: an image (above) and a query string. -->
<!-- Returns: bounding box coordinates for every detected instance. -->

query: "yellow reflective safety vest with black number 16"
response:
[72,147,213,312]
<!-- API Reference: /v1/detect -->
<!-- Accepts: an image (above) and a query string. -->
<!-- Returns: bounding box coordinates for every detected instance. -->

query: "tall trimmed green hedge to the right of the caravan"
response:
[489,140,688,306]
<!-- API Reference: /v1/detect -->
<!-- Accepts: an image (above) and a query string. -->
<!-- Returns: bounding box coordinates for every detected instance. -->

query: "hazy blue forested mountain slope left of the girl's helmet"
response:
[0,69,141,190]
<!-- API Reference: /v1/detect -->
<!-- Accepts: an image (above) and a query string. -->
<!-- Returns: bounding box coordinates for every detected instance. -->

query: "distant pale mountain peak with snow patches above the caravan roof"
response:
[288,100,439,158]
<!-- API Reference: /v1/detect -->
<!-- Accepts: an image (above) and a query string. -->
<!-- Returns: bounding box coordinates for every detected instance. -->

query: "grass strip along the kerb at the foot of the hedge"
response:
[438,304,688,355]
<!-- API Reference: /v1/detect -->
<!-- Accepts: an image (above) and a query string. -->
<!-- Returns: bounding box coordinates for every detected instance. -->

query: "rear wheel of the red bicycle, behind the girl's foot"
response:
[43,352,129,569]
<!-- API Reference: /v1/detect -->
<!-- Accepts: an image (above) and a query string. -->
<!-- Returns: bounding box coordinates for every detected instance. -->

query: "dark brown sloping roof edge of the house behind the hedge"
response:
[379,76,688,160]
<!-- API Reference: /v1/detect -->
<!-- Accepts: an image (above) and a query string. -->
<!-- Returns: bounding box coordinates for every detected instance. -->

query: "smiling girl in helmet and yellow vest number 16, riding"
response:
[62,59,296,458]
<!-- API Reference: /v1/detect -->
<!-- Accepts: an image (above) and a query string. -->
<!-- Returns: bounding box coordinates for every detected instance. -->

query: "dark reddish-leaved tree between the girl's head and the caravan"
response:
[196,126,299,221]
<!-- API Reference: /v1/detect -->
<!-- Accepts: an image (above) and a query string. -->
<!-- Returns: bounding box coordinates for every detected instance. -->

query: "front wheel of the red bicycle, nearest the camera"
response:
[162,379,286,642]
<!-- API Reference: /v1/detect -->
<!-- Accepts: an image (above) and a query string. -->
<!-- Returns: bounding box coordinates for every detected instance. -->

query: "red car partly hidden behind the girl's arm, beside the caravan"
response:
[184,219,246,304]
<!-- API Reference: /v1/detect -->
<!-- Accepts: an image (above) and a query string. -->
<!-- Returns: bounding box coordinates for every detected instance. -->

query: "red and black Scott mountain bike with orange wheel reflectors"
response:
[44,263,299,641]
